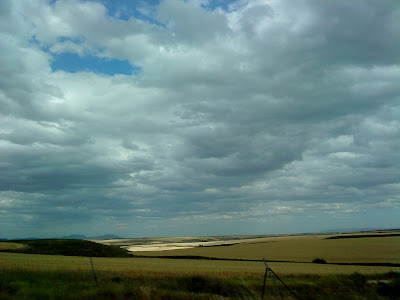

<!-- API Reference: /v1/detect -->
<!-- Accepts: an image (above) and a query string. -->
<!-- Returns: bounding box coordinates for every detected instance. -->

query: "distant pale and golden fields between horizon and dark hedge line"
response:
[96,231,400,265]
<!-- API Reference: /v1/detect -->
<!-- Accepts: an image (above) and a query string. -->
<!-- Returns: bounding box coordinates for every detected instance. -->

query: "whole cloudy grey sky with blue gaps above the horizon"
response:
[0,0,400,238]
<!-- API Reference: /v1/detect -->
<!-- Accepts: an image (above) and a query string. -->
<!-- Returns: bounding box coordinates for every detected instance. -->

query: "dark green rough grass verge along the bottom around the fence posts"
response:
[0,270,400,299]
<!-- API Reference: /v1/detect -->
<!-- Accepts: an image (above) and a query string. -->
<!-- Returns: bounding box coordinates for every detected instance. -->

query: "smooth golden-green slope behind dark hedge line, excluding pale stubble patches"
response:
[134,235,400,263]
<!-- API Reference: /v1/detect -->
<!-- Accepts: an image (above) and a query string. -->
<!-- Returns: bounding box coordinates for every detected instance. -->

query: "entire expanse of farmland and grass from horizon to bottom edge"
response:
[0,232,400,299]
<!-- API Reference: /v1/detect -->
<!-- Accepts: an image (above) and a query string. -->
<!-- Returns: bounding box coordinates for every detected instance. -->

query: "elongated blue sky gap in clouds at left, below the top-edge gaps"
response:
[51,53,140,76]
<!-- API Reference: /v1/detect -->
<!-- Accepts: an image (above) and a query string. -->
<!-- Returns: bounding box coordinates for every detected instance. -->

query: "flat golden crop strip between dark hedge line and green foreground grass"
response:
[0,252,400,277]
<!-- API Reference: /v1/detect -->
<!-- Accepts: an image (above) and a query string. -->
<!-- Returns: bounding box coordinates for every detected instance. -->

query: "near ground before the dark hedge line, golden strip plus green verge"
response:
[0,253,400,299]
